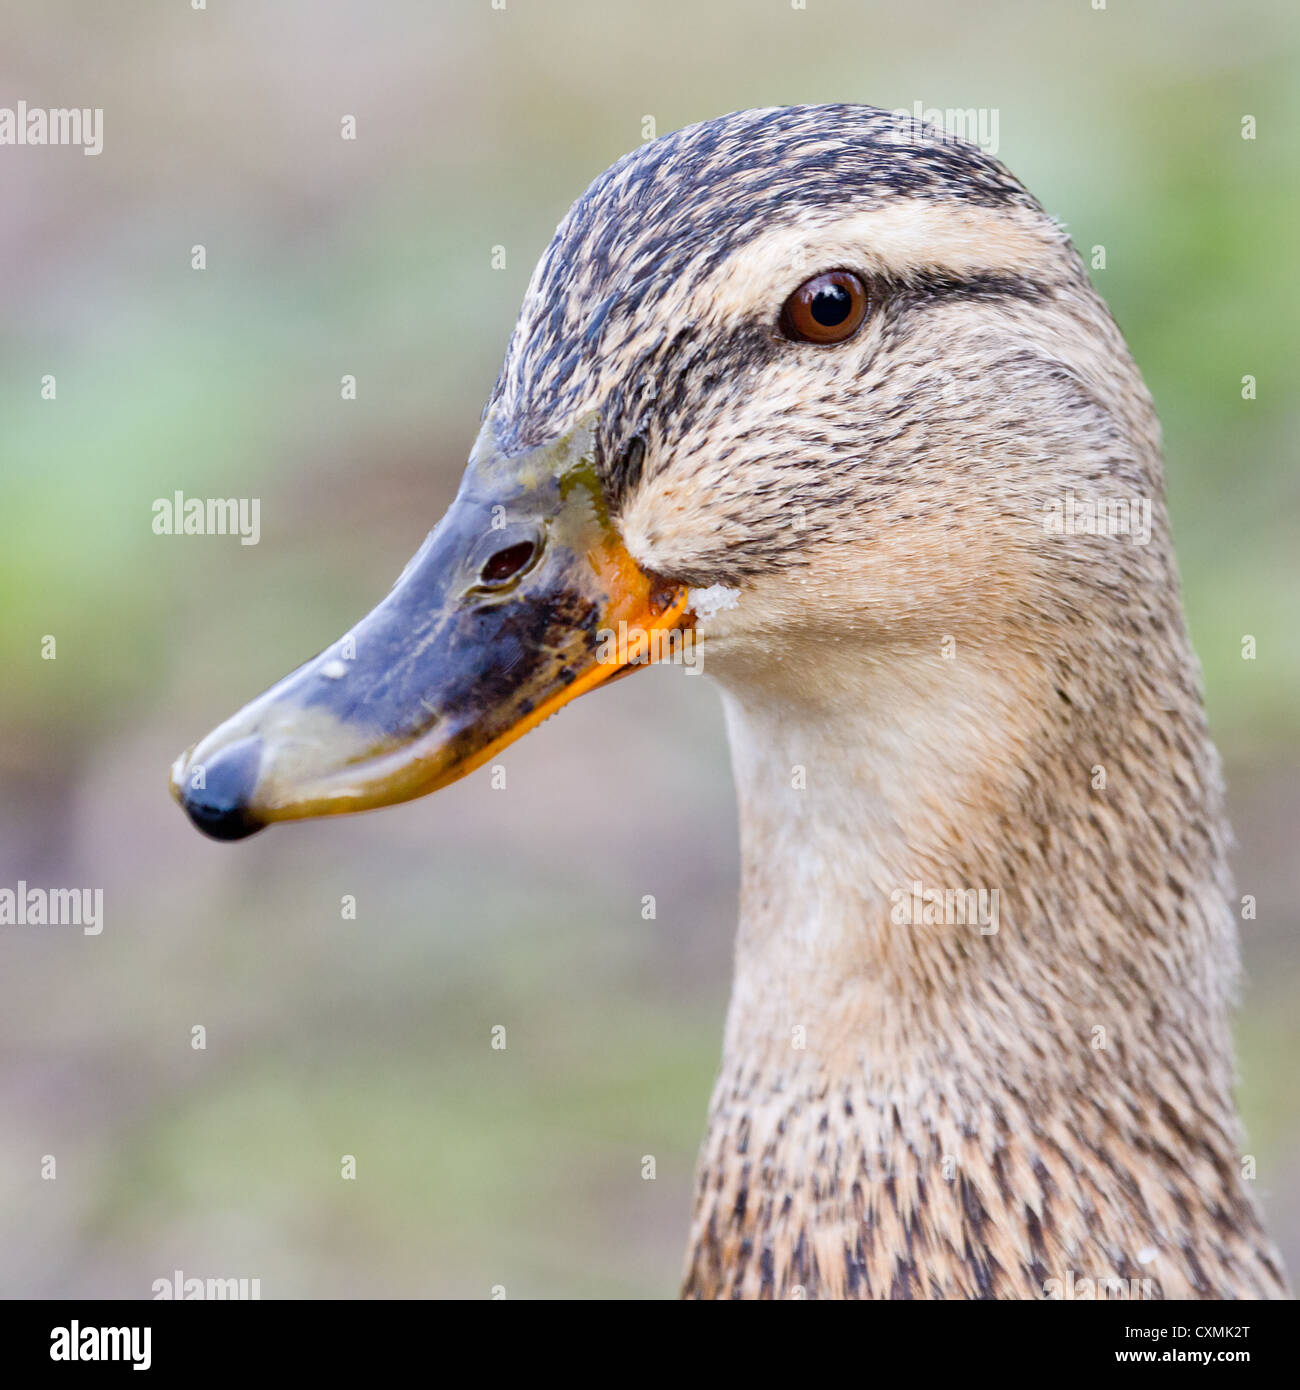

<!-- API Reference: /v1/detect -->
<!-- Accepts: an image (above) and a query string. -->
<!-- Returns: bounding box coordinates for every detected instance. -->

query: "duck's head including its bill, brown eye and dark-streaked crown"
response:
[172,106,1155,840]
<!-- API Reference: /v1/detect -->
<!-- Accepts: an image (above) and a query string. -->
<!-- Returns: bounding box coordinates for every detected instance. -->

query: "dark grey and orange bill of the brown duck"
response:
[172,420,690,840]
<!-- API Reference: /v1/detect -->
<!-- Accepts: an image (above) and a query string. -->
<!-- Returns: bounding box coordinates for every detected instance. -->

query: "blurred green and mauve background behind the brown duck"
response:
[0,0,1300,1297]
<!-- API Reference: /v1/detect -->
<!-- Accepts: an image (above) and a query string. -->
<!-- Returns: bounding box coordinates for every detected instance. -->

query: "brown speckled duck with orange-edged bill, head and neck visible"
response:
[171,104,1287,1300]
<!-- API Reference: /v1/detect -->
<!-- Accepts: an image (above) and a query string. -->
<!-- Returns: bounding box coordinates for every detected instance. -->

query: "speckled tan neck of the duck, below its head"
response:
[685,631,1281,1297]
